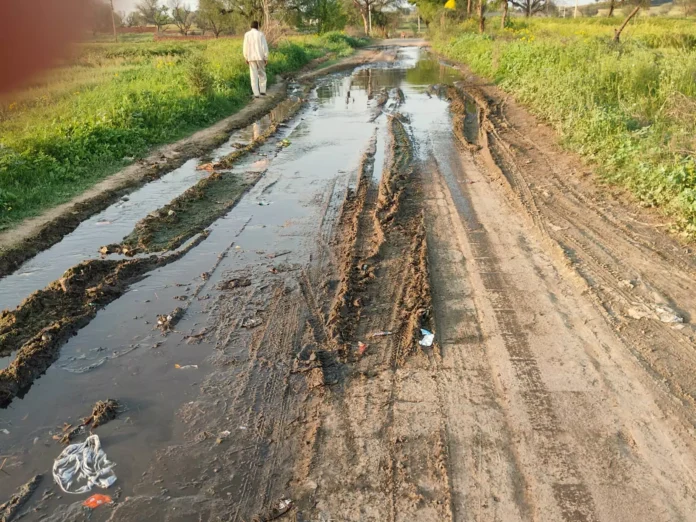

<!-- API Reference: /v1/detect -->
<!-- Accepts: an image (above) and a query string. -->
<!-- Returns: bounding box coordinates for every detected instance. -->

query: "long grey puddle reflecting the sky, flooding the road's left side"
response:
[0,49,462,520]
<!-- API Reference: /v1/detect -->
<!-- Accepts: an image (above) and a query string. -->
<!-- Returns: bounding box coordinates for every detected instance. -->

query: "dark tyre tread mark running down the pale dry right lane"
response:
[440,96,598,522]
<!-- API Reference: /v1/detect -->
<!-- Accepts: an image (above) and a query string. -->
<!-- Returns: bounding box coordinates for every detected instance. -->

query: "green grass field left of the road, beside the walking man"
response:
[0,33,364,229]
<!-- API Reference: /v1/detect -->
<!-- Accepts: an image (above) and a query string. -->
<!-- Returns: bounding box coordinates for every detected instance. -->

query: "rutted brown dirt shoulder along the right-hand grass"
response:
[452,89,696,438]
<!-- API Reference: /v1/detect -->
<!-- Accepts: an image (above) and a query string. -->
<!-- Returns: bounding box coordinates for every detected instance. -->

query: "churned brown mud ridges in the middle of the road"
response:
[329,117,432,364]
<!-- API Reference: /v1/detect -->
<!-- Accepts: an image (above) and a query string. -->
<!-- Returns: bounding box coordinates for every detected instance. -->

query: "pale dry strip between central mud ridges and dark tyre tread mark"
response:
[423,157,534,521]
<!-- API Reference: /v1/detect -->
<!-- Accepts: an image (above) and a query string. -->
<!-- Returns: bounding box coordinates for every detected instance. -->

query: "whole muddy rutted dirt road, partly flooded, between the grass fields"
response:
[0,47,696,522]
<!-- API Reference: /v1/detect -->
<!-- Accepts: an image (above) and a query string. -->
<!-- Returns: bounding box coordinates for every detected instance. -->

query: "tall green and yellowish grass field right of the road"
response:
[433,17,696,236]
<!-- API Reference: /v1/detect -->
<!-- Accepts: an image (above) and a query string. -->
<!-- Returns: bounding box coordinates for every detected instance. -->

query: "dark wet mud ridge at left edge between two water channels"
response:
[0,235,206,408]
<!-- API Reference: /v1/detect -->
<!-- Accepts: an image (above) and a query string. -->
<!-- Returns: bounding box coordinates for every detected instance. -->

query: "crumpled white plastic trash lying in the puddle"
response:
[53,435,116,495]
